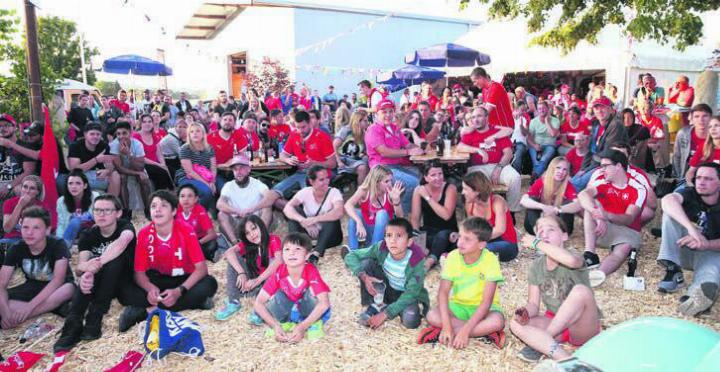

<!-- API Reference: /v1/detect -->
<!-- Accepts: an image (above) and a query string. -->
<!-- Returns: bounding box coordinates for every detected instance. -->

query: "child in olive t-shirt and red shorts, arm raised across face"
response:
[510,215,602,363]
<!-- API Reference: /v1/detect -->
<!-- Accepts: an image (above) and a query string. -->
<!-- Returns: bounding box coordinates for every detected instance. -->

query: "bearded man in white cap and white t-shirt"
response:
[216,155,275,245]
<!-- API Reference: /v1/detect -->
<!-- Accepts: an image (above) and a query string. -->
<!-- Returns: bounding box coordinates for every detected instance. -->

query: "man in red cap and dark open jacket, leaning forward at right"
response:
[572,96,630,191]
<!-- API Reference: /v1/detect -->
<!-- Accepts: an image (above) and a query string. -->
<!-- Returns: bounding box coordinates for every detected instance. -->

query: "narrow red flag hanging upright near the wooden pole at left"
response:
[40,105,60,230]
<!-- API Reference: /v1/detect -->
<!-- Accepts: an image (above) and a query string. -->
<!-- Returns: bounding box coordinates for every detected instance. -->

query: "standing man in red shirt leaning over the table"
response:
[470,67,515,128]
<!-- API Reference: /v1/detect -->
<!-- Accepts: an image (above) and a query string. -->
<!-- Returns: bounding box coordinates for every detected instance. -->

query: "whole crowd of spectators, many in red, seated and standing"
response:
[0,68,720,362]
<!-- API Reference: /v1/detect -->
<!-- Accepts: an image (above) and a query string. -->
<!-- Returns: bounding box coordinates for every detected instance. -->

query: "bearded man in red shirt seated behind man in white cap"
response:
[207,111,247,190]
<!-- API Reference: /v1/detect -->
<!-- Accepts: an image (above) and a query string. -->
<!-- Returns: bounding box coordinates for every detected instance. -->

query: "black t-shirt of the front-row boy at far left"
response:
[3,236,73,282]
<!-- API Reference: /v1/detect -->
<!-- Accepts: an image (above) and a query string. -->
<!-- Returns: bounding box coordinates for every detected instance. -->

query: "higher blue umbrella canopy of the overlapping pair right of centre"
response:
[405,43,490,67]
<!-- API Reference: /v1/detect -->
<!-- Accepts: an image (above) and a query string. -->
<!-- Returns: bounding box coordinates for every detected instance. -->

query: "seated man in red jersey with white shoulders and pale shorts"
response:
[578,149,647,286]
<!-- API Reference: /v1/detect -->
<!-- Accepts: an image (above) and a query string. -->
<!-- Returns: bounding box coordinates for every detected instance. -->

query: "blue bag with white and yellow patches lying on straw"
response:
[143,309,205,359]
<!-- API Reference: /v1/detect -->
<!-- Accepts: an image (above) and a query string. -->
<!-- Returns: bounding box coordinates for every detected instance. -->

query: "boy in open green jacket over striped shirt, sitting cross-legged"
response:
[345,217,430,329]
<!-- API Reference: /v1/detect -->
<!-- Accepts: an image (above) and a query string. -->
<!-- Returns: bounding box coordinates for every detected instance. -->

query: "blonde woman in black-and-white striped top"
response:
[175,123,217,210]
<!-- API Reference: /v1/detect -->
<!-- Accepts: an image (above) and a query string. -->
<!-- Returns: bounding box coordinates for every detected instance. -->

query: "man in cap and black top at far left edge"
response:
[0,114,36,200]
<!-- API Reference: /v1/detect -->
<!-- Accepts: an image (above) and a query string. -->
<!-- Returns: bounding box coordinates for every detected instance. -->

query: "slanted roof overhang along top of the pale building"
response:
[175,0,481,40]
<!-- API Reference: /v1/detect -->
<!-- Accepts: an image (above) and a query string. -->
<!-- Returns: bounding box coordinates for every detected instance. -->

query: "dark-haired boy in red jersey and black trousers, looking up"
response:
[119,190,217,332]
